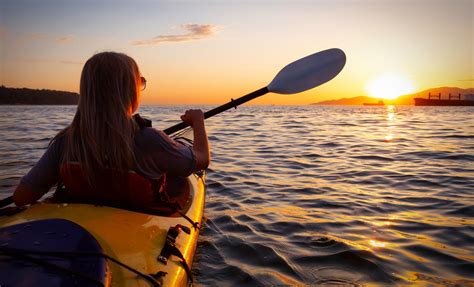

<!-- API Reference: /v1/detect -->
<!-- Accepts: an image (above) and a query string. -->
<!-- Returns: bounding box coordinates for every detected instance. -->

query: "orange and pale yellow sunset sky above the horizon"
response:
[0,0,474,105]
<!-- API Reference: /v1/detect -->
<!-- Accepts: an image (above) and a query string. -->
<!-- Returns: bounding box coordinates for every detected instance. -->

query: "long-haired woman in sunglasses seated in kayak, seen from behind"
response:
[13,52,210,208]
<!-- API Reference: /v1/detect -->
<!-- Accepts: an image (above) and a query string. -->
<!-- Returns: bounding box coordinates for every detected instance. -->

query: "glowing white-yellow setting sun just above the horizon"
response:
[366,75,415,100]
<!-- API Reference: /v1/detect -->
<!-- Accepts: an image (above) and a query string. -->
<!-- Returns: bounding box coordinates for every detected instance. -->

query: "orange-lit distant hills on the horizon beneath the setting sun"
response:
[311,87,474,106]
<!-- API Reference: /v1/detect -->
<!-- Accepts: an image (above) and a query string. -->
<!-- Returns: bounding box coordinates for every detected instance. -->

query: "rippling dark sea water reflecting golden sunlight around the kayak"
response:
[0,106,474,286]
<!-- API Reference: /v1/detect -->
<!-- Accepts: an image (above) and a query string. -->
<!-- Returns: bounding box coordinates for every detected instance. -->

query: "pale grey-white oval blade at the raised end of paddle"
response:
[267,48,346,94]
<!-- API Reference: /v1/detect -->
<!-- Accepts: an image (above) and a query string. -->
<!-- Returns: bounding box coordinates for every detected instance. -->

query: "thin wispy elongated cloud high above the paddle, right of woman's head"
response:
[131,24,217,46]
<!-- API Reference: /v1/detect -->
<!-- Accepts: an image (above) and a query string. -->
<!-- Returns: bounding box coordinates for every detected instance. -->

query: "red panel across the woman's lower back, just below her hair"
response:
[55,163,163,209]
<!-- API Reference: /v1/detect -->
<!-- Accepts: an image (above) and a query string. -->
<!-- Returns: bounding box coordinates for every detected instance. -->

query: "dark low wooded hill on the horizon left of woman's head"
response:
[0,86,79,105]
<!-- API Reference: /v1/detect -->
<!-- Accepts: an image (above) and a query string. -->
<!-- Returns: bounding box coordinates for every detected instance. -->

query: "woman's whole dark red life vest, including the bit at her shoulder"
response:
[53,117,194,216]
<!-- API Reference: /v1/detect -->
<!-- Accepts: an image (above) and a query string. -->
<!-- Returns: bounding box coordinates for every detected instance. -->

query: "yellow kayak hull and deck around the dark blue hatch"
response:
[0,174,205,286]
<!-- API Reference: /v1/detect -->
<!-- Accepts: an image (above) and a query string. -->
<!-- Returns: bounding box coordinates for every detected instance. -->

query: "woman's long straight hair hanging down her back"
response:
[57,52,141,184]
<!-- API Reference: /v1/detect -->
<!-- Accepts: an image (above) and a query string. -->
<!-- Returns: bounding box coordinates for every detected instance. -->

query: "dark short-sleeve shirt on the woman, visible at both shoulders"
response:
[20,128,196,196]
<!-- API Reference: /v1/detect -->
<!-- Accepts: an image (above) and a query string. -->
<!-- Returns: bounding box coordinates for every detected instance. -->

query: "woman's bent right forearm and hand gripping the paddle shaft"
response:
[181,110,211,170]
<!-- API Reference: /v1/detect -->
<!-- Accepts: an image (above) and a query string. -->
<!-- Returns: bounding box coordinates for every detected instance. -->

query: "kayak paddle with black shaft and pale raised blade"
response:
[164,49,346,135]
